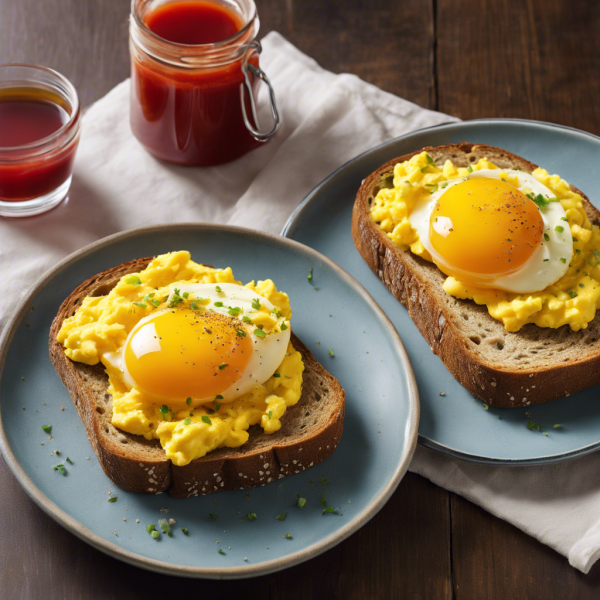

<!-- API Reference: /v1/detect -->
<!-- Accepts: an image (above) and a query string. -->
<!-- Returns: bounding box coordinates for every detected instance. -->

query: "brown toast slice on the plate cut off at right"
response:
[352,142,600,408]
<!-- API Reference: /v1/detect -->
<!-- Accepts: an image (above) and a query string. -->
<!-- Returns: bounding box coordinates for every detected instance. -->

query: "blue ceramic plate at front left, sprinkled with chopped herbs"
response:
[0,224,419,578]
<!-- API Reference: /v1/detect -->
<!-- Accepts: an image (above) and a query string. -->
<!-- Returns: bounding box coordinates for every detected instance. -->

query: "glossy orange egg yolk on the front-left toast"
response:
[125,309,252,400]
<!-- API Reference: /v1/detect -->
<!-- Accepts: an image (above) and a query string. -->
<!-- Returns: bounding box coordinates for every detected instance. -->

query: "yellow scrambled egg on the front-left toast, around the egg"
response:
[57,252,304,466]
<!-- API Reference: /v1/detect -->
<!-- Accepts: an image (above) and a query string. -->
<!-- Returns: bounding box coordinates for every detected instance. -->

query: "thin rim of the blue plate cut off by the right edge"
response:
[281,117,600,467]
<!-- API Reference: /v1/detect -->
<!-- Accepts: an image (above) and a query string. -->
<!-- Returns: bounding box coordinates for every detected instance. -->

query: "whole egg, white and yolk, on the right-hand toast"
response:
[409,169,573,293]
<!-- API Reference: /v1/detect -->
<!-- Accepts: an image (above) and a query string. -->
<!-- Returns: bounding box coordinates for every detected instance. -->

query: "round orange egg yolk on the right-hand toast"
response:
[429,178,544,284]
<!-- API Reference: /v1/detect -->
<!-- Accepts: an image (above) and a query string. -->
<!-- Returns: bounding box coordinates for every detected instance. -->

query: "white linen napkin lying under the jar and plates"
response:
[0,33,600,573]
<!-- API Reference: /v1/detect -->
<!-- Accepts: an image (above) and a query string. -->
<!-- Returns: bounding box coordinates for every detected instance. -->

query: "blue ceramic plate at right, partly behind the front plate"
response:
[283,119,600,465]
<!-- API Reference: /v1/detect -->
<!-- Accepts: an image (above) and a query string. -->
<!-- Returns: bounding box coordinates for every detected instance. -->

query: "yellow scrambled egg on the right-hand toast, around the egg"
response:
[371,152,600,331]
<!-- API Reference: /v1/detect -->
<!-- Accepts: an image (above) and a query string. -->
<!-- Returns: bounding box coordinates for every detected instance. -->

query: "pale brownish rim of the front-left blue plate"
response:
[0,222,420,579]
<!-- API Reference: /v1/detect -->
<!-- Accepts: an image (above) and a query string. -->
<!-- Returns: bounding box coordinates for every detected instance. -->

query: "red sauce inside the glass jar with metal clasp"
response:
[130,0,260,165]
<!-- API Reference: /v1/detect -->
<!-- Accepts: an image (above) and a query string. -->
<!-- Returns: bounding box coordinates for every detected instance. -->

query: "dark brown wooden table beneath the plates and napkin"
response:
[0,0,600,600]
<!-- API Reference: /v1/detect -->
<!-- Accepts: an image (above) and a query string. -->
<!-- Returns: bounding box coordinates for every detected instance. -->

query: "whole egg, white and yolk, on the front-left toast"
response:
[102,283,290,409]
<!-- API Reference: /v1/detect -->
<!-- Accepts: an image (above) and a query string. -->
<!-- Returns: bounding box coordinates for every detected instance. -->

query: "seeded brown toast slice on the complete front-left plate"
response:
[49,258,345,498]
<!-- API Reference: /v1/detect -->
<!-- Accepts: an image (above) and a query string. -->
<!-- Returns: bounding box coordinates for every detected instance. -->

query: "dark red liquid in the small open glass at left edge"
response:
[0,88,77,202]
